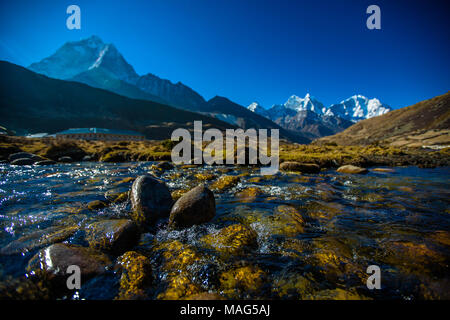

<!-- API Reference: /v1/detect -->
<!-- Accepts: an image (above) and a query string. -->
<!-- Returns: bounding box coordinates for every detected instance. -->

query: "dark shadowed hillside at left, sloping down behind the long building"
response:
[0,61,234,139]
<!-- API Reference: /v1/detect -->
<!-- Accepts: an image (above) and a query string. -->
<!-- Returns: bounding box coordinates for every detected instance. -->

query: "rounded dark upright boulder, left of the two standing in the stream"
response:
[130,175,173,225]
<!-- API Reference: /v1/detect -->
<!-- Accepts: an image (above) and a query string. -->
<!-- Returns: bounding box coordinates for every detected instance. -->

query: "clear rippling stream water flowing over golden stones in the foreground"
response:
[0,162,450,299]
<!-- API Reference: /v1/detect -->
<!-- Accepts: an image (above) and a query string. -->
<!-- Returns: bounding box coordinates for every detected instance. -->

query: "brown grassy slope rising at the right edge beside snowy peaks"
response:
[315,92,450,147]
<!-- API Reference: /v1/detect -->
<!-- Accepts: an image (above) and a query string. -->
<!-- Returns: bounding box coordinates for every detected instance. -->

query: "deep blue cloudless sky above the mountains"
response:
[0,0,450,108]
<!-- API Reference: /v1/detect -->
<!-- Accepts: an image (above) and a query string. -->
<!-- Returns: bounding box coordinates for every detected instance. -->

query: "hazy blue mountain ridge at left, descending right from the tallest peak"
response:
[28,36,302,143]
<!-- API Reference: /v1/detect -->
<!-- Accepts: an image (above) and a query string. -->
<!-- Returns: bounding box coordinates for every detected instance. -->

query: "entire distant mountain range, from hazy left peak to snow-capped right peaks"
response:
[28,36,398,143]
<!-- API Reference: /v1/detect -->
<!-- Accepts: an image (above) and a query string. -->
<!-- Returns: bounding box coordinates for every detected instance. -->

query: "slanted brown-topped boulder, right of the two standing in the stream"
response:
[169,184,216,229]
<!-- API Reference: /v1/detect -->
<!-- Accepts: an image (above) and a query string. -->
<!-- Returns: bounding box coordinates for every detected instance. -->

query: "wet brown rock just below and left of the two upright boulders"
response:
[86,219,140,255]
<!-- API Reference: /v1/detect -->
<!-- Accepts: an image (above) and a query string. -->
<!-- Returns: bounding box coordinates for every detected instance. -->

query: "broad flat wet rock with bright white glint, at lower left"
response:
[28,243,111,281]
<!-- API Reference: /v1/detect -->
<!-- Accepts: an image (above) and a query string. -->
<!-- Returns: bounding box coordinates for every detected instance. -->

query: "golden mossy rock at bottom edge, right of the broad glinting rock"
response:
[116,251,152,300]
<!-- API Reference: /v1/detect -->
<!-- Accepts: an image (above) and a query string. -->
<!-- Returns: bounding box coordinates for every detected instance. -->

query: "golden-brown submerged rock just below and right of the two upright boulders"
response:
[200,224,257,255]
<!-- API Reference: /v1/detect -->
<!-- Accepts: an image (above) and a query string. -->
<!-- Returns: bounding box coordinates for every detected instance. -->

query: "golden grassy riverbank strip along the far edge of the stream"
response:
[0,136,450,168]
